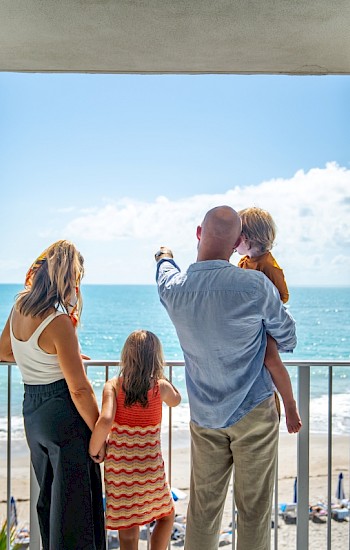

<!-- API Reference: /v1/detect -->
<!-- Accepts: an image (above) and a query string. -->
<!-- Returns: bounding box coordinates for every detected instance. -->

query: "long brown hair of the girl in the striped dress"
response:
[120,330,164,407]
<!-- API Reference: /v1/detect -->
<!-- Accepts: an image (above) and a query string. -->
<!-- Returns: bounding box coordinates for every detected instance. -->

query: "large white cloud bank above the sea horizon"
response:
[60,163,350,286]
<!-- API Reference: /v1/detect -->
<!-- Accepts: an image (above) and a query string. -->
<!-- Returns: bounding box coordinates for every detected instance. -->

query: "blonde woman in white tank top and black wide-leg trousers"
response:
[0,240,105,550]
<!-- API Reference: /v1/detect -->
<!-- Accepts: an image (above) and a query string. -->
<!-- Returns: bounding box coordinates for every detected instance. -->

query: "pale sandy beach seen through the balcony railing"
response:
[0,430,350,550]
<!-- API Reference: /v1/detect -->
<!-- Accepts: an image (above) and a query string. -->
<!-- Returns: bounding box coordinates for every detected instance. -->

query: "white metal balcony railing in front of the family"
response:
[0,360,350,550]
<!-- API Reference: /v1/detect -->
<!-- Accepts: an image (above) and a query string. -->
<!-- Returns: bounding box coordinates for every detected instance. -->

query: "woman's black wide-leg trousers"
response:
[23,380,106,550]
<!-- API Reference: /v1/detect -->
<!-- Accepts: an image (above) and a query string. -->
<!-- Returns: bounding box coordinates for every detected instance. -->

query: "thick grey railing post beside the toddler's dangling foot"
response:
[297,366,310,550]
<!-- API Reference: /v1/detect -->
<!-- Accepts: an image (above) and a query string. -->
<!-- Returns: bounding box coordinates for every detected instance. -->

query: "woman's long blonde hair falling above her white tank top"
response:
[16,240,84,324]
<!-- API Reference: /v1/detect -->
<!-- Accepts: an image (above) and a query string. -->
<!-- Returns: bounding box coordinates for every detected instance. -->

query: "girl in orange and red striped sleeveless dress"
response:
[89,330,181,550]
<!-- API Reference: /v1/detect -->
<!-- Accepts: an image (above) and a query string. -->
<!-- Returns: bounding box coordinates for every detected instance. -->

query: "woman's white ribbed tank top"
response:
[10,311,64,385]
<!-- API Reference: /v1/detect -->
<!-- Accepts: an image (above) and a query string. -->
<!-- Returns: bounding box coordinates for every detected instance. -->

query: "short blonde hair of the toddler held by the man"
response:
[238,206,277,253]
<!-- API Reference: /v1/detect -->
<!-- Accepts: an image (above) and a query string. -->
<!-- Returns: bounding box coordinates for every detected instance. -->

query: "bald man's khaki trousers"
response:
[185,396,279,550]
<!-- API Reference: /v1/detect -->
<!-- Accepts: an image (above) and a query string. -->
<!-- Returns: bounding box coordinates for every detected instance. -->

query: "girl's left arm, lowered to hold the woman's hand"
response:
[89,381,117,458]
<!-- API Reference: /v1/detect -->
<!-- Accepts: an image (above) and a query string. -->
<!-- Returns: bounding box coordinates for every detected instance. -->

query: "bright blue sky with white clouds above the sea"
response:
[0,73,350,285]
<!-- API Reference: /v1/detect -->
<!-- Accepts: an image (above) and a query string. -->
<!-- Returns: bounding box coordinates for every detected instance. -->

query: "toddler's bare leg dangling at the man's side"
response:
[265,335,302,433]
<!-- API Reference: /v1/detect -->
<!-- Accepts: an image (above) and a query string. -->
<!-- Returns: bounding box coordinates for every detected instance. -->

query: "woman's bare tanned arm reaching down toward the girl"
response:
[46,315,99,431]
